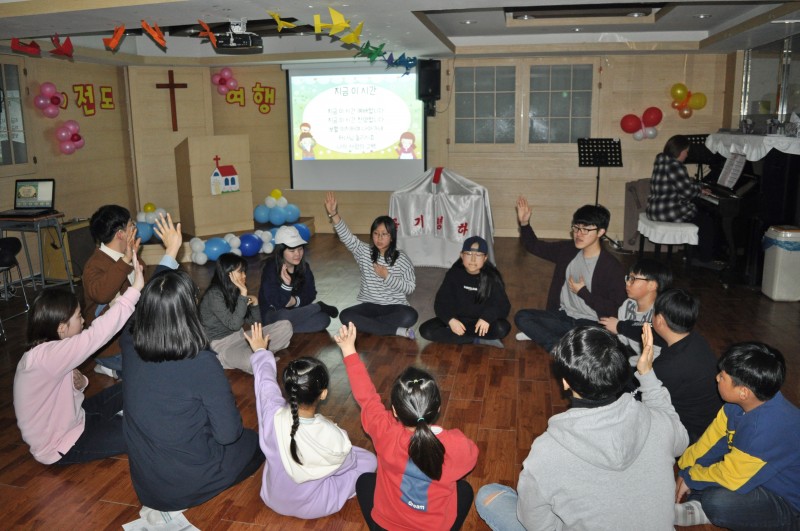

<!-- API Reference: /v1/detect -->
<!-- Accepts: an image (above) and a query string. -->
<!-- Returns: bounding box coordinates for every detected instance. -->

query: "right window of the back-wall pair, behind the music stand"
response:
[528,64,593,144]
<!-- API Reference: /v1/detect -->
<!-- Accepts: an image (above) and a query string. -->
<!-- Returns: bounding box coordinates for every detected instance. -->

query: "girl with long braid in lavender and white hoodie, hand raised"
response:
[251,325,377,518]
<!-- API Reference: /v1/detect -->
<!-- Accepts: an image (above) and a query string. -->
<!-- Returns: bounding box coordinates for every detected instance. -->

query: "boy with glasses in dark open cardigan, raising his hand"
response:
[514,196,625,352]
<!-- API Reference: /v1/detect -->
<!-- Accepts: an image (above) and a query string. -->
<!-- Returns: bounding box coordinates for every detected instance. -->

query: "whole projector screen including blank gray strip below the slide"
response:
[288,63,425,191]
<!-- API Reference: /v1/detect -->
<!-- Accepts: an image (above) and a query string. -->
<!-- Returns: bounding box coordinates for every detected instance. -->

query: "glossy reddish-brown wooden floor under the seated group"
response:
[0,234,800,530]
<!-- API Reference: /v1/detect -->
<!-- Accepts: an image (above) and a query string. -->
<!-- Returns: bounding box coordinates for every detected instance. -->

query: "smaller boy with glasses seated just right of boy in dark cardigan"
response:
[599,258,672,367]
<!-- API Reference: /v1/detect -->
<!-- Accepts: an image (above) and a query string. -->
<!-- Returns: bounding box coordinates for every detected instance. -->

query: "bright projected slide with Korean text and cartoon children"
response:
[291,73,423,161]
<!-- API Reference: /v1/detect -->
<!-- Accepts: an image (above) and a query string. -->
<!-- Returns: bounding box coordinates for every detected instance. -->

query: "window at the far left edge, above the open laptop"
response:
[0,57,29,169]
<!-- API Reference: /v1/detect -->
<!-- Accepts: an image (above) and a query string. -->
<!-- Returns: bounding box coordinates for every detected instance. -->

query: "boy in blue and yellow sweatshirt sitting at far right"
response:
[675,343,800,530]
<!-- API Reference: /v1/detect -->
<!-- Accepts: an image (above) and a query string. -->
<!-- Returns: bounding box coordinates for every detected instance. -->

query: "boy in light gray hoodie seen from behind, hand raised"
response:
[475,324,689,531]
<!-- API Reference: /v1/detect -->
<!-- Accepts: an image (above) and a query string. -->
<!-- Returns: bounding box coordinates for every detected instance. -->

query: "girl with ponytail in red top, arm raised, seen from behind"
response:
[334,323,478,530]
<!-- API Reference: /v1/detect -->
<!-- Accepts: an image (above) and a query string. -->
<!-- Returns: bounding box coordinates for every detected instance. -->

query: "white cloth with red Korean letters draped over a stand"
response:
[389,168,495,268]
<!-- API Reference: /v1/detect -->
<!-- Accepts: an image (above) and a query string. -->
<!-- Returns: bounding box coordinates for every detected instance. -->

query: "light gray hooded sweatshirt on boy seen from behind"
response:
[517,371,689,531]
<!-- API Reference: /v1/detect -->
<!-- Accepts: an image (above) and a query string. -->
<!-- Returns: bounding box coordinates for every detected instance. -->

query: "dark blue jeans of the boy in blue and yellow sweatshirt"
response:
[689,487,800,531]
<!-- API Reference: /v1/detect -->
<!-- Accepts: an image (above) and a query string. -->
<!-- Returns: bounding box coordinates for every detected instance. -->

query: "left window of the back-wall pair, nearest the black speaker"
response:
[455,66,516,144]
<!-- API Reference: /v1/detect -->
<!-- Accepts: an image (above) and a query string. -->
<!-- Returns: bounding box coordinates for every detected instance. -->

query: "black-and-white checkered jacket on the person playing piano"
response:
[647,153,701,221]
